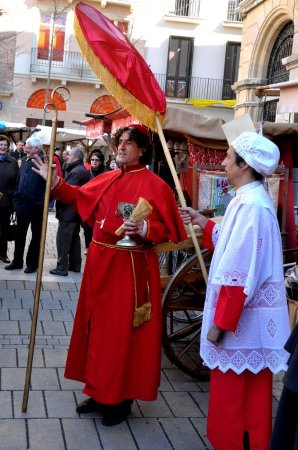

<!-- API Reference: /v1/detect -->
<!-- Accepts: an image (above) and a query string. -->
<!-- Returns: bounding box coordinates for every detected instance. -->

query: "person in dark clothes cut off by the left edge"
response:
[0,135,19,263]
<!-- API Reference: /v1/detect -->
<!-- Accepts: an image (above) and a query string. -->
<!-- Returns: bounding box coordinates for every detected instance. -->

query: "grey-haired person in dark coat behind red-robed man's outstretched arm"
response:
[50,146,90,276]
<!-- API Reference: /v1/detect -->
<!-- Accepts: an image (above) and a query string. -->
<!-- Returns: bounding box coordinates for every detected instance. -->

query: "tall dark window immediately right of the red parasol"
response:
[166,36,194,98]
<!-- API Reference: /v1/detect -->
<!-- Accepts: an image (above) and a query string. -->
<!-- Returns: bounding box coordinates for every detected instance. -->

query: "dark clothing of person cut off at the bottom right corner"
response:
[270,324,298,450]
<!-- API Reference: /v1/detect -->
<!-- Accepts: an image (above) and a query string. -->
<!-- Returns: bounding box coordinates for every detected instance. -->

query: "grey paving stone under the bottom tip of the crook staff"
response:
[13,391,47,419]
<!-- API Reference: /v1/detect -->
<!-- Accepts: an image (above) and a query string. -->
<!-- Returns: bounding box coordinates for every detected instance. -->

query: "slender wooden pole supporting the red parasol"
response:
[156,116,208,285]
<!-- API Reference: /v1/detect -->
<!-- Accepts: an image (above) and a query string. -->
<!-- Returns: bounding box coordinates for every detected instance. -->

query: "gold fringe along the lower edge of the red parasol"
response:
[74,15,165,131]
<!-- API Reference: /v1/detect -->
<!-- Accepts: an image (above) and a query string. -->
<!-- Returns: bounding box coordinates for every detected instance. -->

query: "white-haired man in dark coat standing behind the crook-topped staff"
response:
[5,136,46,273]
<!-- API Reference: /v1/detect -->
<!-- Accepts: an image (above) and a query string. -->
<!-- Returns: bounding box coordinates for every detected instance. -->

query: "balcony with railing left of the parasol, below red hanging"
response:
[30,48,97,82]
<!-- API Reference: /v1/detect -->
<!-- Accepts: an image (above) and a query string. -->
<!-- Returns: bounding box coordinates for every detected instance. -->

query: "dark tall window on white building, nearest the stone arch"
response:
[222,42,241,100]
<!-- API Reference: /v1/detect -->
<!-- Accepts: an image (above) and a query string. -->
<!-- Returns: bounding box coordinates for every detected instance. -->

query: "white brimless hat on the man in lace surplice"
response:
[231,131,280,176]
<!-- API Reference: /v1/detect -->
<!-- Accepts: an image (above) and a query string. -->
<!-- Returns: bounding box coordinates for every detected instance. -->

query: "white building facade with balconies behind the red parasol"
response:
[0,0,242,128]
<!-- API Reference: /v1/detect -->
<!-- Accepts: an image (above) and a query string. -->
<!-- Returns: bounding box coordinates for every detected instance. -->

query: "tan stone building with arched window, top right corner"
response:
[234,0,298,122]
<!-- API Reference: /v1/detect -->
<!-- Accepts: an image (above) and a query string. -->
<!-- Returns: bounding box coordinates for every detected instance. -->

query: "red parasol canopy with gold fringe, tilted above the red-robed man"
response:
[74,2,166,130]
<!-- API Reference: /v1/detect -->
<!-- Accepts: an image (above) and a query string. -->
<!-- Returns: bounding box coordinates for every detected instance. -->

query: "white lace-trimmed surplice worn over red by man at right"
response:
[200,182,290,374]
